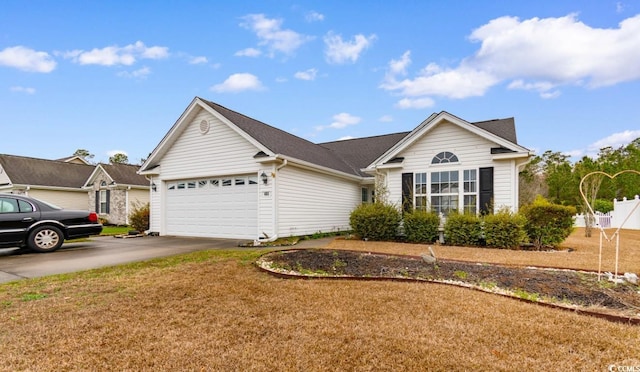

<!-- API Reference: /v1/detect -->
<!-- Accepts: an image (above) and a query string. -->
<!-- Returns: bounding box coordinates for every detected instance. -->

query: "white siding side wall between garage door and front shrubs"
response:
[276,165,362,237]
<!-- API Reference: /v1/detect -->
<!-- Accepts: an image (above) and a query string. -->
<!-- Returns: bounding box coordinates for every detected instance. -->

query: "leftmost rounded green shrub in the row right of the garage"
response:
[349,203,401,241]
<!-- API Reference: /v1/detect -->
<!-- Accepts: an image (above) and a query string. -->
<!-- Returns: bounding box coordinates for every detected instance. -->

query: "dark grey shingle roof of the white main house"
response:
[142,97,528,176]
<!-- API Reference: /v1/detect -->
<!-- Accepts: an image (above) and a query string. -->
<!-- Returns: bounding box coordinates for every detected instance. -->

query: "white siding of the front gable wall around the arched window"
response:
[384,122,518,214]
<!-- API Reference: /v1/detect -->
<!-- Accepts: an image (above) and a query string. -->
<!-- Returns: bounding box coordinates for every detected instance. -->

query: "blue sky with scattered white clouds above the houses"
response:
[0,0,640,163]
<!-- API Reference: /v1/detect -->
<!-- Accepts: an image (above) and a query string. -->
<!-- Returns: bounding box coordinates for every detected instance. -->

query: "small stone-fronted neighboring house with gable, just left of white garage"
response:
[84,164,149,225]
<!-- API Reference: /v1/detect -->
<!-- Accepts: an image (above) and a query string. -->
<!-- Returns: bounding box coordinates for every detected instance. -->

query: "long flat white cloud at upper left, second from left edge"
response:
[63,41,169,66]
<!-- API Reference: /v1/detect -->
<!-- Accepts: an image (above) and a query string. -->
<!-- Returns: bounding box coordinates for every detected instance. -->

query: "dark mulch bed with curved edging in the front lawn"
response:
[260,249,640,320]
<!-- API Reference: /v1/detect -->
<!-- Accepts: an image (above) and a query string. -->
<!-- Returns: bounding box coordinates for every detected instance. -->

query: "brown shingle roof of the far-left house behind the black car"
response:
[0,154,94,188]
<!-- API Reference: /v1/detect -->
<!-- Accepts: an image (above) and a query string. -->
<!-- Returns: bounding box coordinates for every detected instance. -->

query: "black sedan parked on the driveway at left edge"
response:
[0,194,102,252]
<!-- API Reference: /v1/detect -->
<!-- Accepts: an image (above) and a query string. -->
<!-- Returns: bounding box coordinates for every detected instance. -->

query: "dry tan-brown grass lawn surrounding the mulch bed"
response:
[0,230,640,371]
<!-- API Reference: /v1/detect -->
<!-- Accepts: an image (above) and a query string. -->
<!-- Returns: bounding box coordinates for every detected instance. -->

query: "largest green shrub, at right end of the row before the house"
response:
[521,195,576,249]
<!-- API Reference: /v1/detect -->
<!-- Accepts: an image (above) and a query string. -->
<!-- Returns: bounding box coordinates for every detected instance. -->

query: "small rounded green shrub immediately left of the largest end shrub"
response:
[483,209,527,249]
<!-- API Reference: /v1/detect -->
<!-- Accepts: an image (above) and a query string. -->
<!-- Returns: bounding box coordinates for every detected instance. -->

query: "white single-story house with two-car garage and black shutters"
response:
[139,97,530,240]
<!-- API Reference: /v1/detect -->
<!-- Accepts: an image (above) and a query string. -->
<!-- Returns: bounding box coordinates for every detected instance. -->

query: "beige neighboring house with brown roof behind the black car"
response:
[0,154,95,210]
